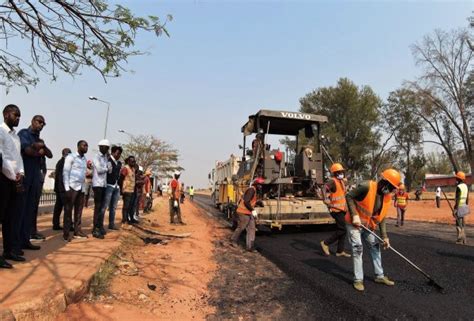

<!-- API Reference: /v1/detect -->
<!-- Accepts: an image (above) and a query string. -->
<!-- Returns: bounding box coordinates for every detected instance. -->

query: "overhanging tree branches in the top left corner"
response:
[0,0,172,89]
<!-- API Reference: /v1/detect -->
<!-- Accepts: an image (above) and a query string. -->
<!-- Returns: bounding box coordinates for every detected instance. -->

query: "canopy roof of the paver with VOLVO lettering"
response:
[242,109,328,136]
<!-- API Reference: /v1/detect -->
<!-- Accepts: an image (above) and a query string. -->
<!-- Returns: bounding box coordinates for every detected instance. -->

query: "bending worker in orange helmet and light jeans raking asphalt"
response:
[345,168,401,291]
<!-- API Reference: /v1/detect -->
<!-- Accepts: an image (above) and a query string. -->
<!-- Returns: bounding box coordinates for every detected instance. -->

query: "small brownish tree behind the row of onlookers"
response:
[123,135,183,178]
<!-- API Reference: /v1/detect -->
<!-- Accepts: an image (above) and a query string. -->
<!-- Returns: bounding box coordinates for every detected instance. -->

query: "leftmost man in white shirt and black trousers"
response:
[0,105,25,269]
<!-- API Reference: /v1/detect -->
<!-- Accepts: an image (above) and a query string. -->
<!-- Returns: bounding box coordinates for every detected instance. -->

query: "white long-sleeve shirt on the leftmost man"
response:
[0,123,25,181]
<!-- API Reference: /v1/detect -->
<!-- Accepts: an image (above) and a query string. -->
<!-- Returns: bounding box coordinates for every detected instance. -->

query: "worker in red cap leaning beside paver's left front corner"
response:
[230,177,265,252]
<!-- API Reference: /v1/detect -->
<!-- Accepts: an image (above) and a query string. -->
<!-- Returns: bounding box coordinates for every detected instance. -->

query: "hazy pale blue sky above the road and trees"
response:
[0,0,474,187]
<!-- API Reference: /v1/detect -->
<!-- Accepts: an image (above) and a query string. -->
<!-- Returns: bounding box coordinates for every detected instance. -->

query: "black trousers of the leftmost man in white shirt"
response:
[0,171,21,253]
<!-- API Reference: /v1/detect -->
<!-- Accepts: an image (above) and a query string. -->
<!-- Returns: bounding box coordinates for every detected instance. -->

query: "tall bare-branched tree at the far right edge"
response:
[411,29,474,172]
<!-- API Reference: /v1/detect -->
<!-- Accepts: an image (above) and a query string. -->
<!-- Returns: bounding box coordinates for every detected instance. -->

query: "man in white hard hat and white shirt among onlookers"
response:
[92,139,110,239]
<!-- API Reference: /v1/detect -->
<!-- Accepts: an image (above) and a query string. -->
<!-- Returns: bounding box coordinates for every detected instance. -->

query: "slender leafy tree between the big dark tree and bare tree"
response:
[382,88,423,191]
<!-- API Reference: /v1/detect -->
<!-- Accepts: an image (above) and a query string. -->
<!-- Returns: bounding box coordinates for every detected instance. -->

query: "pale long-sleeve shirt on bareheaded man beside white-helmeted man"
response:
[63,152,87,192]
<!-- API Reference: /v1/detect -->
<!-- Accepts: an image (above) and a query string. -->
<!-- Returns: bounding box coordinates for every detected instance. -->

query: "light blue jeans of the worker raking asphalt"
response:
[346,224,384,281]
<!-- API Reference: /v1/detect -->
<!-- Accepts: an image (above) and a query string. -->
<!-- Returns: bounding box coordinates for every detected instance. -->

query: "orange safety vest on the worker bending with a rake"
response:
[345,181,392,230]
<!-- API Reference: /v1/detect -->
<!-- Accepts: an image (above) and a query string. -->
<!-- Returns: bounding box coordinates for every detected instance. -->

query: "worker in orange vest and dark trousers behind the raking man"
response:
[321,163,351,257]
